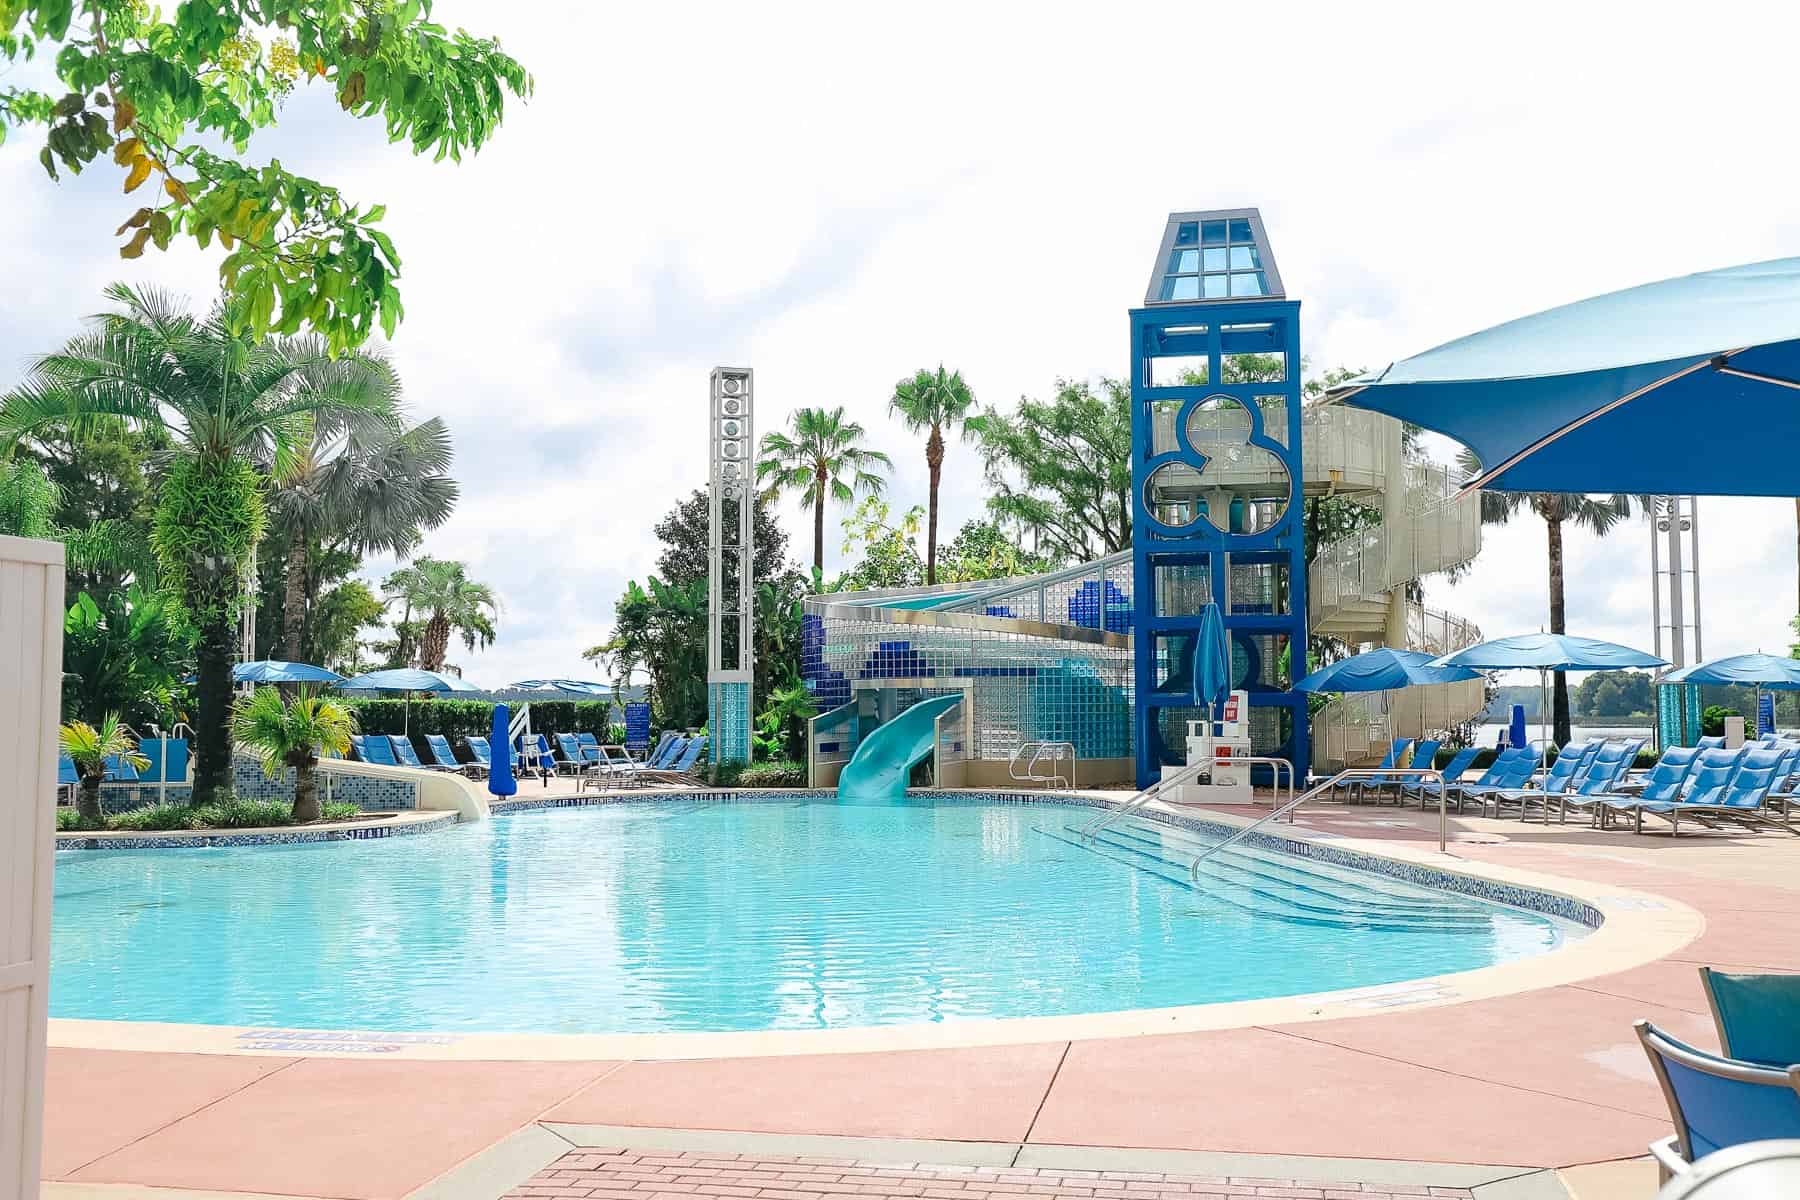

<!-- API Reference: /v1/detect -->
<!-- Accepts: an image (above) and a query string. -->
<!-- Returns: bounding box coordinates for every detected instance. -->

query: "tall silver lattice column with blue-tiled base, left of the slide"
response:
[706,367,756,763]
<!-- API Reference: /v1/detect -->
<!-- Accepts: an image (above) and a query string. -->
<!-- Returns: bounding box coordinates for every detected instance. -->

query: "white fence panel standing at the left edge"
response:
[0,538,63,1200]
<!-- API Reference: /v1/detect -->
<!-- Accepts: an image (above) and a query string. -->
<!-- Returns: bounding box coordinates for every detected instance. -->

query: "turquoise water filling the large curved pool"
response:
[50,801,1580,1033]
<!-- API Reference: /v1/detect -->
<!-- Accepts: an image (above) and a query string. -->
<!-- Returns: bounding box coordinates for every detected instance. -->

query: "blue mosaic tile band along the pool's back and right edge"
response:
[490,788,1606,928]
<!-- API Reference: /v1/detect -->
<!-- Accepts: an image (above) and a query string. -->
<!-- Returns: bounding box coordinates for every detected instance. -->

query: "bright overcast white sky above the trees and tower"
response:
[0,0,1800,685]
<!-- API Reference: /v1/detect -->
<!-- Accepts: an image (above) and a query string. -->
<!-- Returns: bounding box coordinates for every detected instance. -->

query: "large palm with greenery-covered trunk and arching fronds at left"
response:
[0,284,392,804]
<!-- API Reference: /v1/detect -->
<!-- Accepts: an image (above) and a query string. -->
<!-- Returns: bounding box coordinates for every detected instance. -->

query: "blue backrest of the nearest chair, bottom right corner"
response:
[1631,1020,1800,1162]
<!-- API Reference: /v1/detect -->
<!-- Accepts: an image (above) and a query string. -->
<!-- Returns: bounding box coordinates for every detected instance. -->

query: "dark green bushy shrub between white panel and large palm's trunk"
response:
[63,583,194,723]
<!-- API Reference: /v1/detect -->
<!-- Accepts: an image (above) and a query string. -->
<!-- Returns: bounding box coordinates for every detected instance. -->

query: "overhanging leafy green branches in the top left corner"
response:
[0,0,531,351]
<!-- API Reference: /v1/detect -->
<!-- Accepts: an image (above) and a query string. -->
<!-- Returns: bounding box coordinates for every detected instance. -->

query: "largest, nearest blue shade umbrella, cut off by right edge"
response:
[1332,259,1800,497]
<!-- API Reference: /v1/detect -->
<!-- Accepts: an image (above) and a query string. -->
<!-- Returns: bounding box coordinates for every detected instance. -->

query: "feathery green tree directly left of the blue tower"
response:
[965,380,1132,563]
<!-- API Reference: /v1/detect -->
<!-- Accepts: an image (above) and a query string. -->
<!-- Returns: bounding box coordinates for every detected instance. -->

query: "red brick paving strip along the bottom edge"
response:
[508,1148,1474,1200]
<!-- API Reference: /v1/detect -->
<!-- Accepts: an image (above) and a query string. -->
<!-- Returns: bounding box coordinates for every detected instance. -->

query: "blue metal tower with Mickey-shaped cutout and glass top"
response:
[1130,209,1310,788]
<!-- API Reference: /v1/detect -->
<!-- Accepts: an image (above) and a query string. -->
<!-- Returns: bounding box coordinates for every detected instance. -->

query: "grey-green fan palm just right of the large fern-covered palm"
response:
[268,408,459,660]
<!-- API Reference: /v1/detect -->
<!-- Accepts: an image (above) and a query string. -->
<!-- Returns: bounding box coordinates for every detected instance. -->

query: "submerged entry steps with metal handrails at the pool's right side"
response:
[1037,817,1492,936]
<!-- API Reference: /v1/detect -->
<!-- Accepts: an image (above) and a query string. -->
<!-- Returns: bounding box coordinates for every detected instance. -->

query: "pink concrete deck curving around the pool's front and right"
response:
[45,808,1800,1200]
